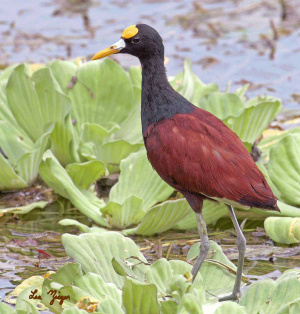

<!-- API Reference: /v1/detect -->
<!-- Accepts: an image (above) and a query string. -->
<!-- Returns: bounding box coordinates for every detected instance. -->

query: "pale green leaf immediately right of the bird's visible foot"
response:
[239,279,276,313]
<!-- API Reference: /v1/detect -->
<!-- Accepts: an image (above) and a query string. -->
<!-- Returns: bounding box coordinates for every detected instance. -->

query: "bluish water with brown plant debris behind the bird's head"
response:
[0,0,300,109]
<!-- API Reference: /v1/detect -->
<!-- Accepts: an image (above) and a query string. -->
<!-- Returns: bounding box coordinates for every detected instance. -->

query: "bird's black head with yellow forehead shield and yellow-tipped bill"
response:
[92,24,164,60]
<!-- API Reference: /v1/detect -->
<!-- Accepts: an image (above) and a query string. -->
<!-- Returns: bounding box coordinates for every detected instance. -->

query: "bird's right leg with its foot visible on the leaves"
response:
[219,206,246,301]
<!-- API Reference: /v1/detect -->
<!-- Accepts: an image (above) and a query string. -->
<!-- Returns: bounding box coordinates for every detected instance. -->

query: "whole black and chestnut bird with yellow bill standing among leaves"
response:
[92,24,280,301]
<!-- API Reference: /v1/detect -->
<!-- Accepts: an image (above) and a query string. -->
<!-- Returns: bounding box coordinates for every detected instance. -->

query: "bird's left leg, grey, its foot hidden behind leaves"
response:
[192,212,209,281]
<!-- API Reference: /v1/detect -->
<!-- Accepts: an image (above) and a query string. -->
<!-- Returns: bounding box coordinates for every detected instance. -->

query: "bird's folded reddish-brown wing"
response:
[144,108,276,208]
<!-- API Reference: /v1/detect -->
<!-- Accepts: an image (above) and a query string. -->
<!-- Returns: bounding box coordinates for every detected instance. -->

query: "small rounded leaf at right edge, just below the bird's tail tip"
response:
[264,217,300,244]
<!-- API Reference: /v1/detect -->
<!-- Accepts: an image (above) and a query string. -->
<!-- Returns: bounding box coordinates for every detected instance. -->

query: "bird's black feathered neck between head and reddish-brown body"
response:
[140,56,192,134]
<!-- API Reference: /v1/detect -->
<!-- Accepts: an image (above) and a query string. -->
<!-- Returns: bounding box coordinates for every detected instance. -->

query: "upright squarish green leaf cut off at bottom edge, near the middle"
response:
[123,277,160,314]
